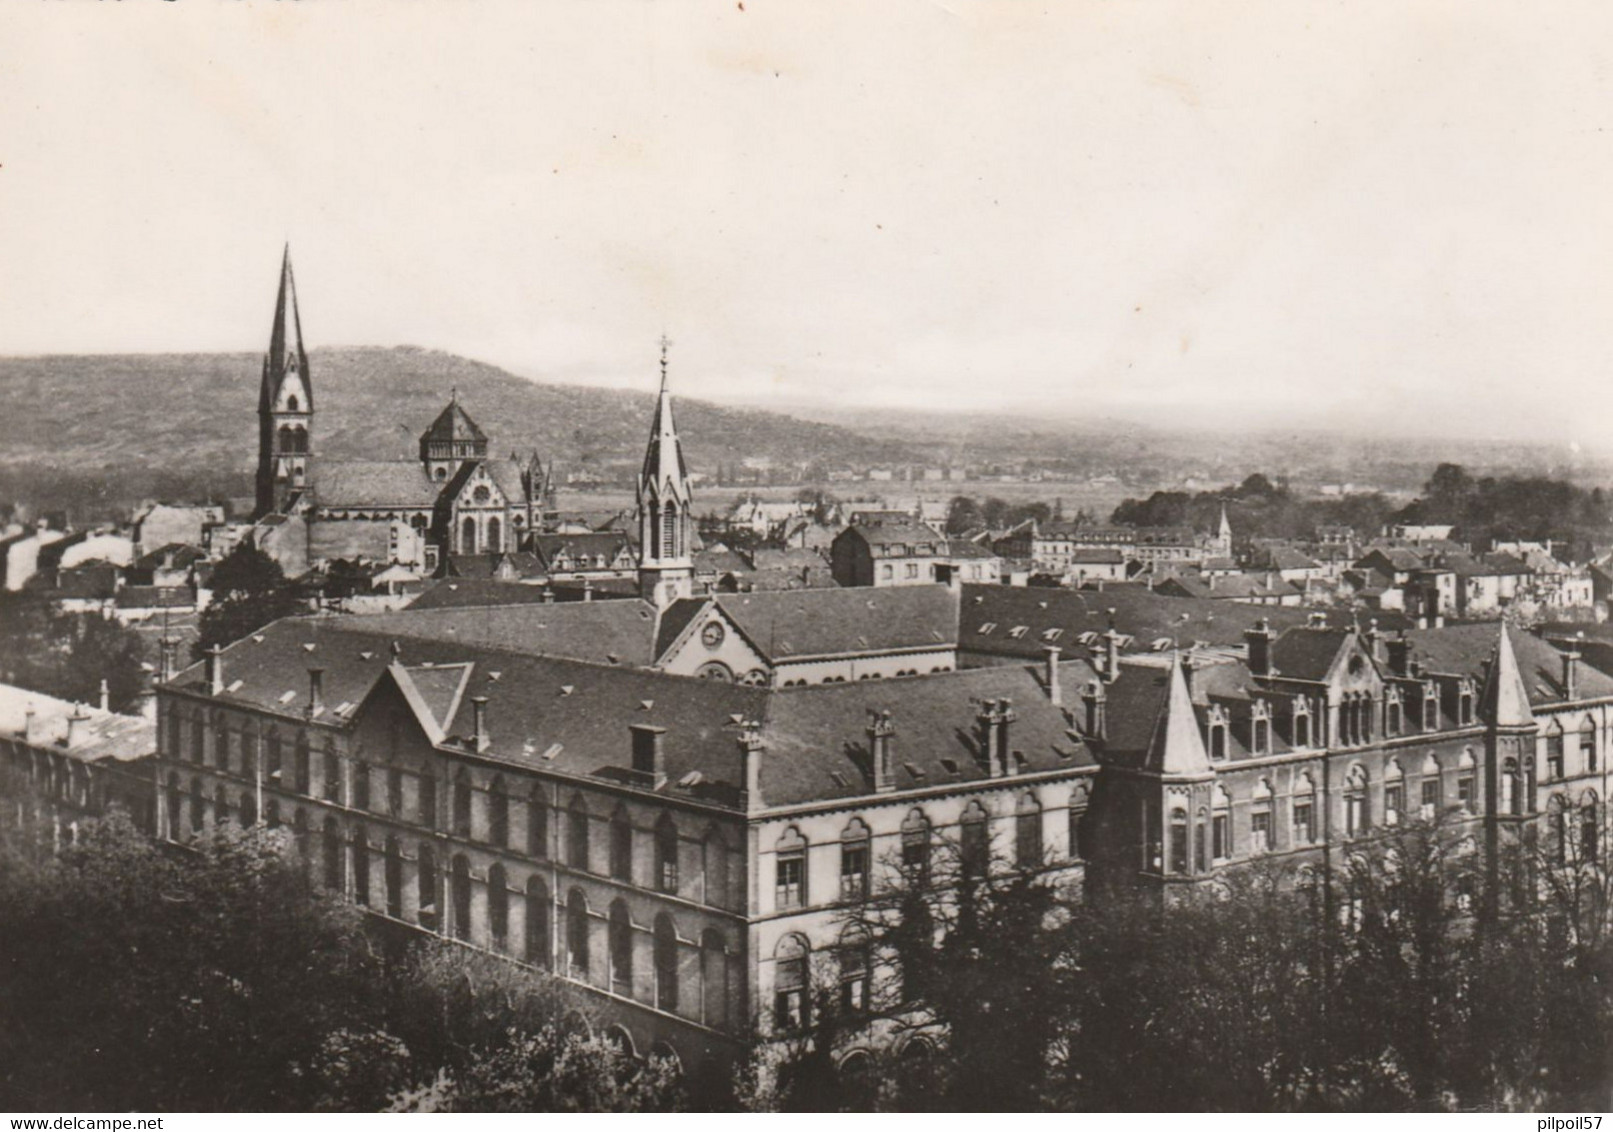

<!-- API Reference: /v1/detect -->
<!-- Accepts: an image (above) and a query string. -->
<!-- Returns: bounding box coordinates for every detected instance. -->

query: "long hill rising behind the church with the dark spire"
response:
[0,347,919,481]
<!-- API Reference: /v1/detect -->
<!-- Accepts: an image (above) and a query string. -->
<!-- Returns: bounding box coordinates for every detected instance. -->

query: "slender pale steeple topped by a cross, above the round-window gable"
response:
[639,335,694,606]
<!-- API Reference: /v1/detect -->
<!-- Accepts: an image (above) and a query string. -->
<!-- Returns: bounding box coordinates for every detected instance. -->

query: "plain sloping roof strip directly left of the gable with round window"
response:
[342,599,656,666]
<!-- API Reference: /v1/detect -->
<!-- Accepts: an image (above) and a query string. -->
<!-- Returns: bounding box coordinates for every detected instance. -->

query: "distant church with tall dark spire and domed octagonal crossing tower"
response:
[253,250,553,574]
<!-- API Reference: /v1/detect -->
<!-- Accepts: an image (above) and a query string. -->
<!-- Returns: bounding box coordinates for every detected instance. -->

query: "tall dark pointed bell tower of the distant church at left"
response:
[256,243,313,518]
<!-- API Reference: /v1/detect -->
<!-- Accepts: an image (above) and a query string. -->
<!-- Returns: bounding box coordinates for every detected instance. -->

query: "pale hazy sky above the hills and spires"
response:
[0,0,1613,443]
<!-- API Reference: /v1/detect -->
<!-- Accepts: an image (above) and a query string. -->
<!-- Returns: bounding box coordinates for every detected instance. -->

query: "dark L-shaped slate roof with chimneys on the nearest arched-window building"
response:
[174,618,1095,806]
